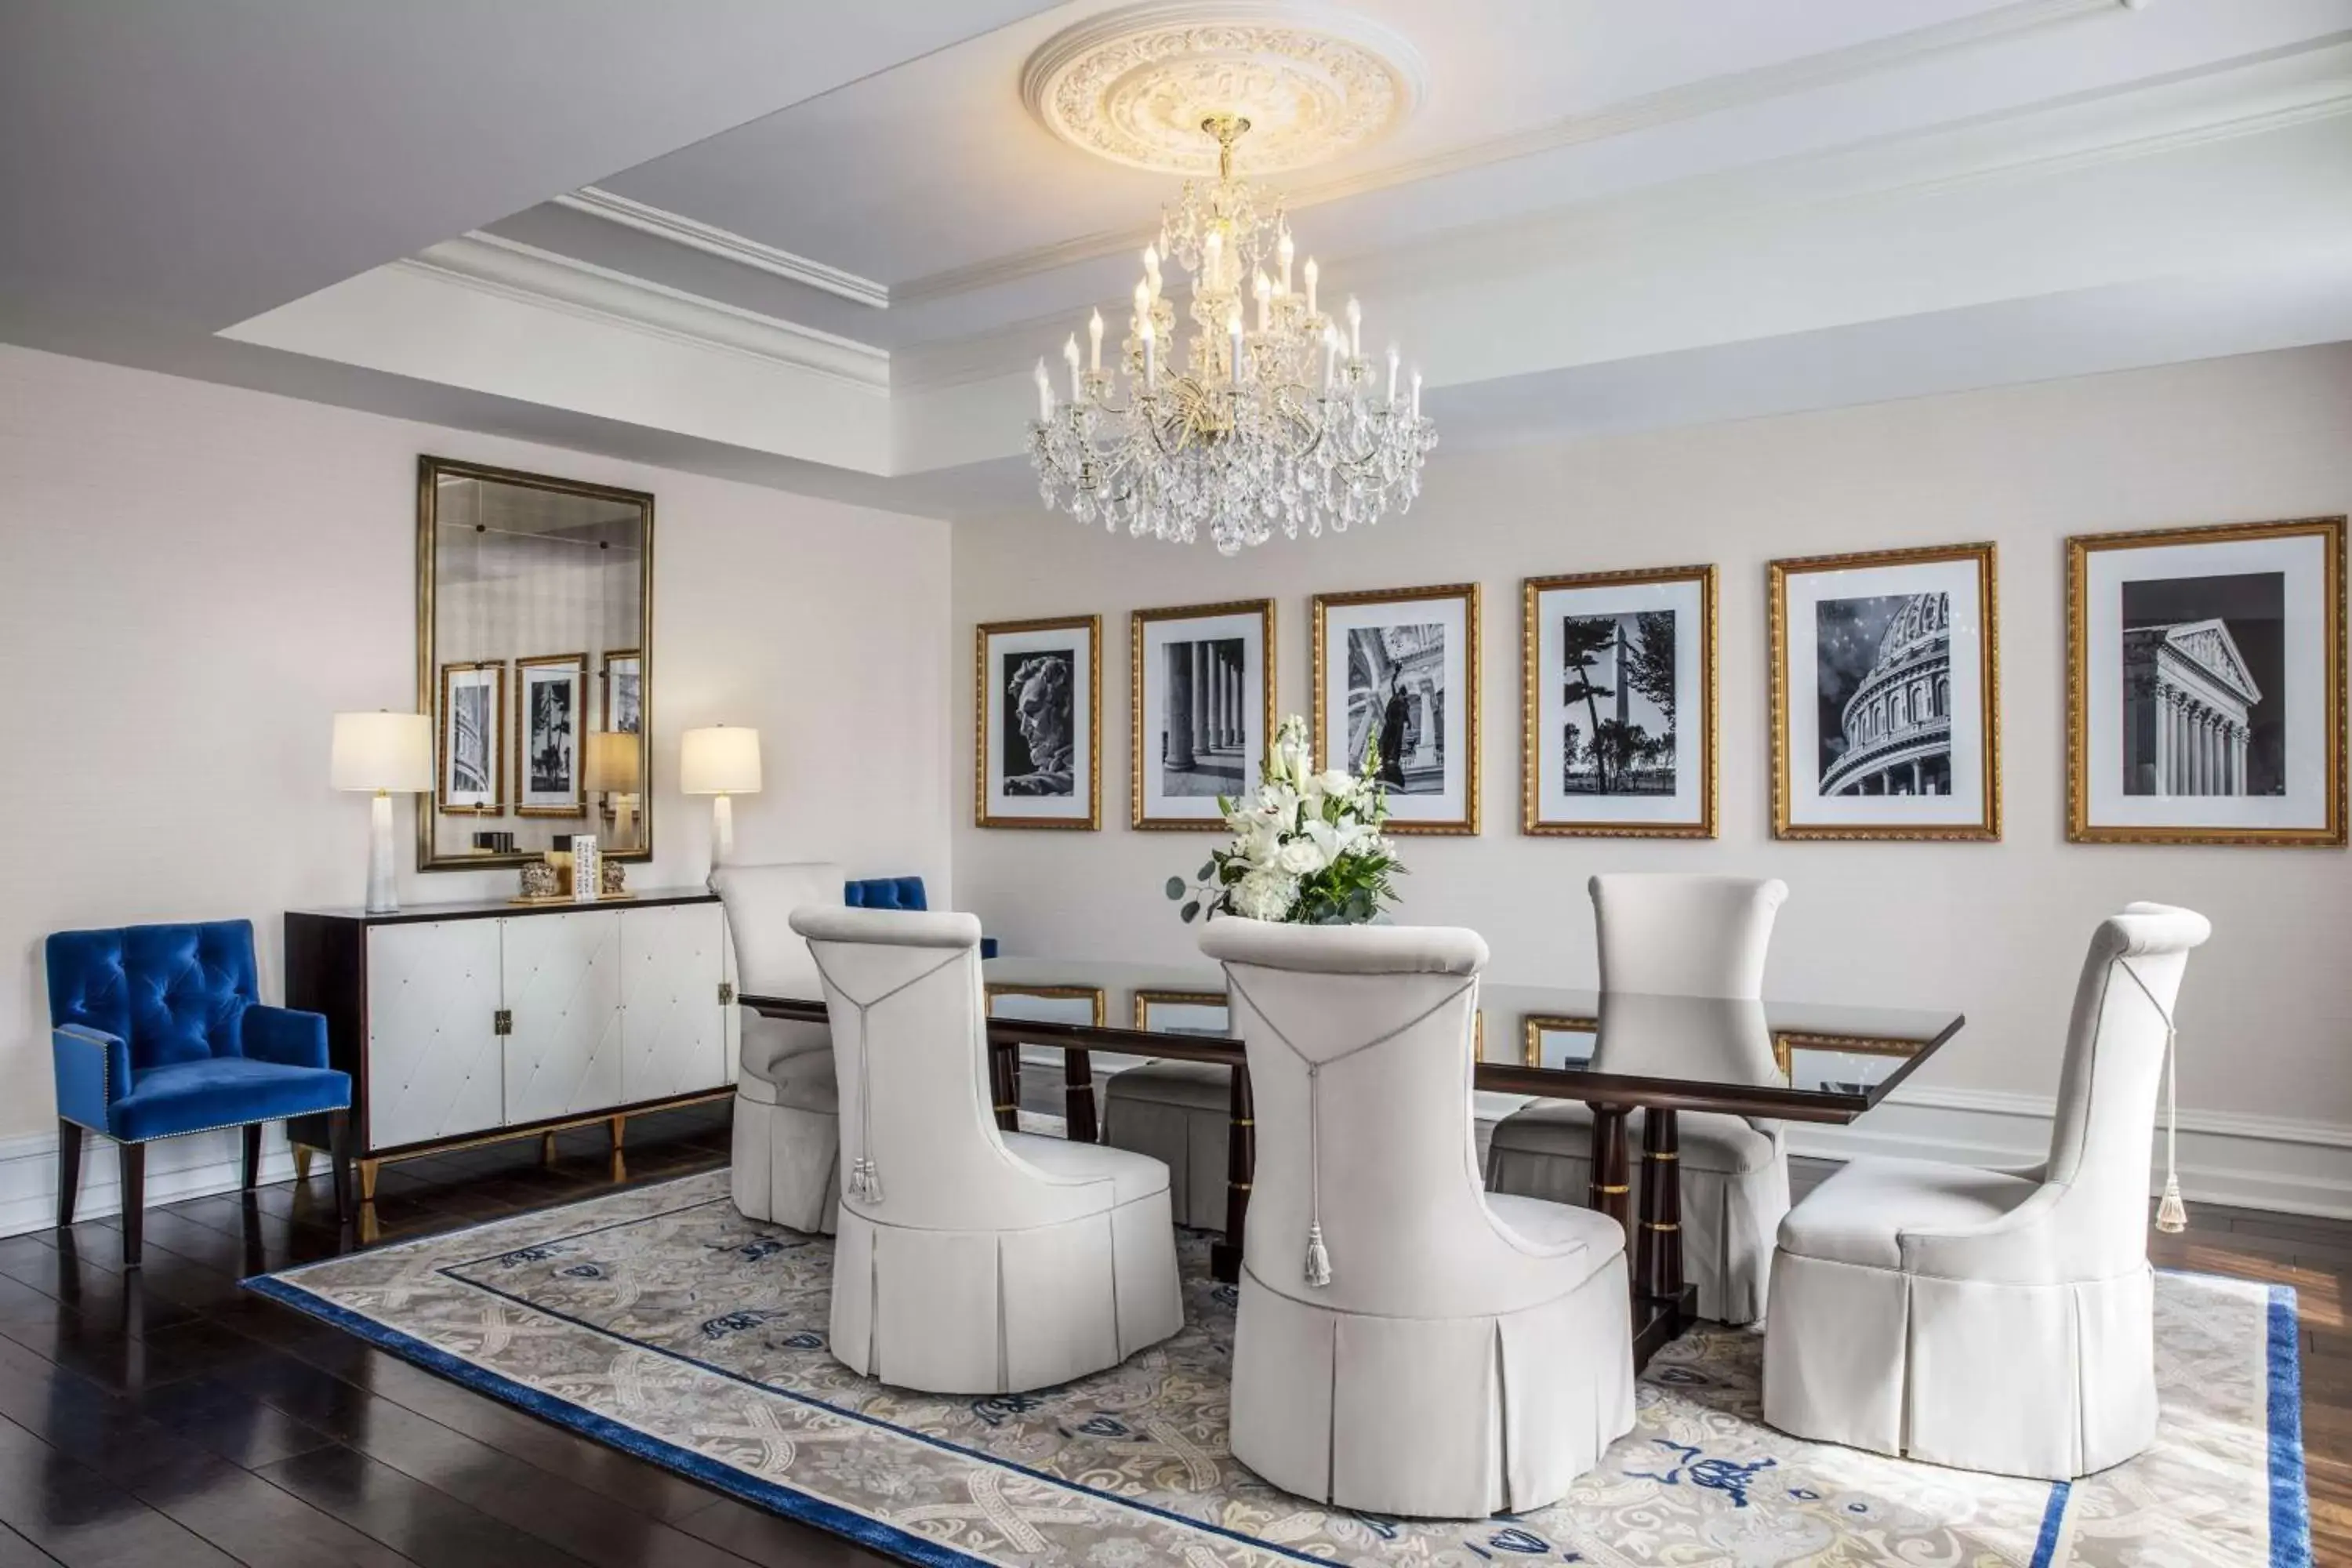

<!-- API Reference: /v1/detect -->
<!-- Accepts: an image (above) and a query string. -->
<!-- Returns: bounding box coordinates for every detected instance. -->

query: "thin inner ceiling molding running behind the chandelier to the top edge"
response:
[891,0,2136,306]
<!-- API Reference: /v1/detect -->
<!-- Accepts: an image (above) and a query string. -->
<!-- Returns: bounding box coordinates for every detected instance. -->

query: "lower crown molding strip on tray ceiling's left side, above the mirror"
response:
[393,233,889,395]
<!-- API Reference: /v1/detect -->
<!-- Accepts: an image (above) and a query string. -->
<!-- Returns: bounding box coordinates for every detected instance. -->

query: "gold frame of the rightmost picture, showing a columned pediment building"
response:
[2065,517,2347,848]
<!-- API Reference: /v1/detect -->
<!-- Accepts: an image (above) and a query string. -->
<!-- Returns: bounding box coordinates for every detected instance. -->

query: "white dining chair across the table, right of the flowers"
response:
[1486,874,1788,1323]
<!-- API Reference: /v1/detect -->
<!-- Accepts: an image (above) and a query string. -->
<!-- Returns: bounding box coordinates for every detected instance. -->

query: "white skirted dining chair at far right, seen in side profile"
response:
[1764,902,2213,1481]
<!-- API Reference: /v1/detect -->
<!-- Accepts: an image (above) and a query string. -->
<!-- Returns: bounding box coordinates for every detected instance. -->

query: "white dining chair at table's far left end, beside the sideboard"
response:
[710,860,842,1234]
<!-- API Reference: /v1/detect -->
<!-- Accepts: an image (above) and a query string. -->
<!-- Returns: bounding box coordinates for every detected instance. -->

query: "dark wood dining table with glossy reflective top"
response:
[741,956,1964,1361]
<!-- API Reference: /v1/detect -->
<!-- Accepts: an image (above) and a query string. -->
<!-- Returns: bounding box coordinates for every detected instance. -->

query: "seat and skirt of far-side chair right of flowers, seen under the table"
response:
[1486,1100,1788,1323]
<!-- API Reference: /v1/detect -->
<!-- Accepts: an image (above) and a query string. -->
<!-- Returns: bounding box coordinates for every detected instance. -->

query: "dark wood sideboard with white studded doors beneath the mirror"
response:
[285,888,736,1203]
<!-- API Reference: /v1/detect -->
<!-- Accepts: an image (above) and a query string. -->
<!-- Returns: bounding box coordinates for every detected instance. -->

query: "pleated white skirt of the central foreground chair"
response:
[1232,1225,1635,1519]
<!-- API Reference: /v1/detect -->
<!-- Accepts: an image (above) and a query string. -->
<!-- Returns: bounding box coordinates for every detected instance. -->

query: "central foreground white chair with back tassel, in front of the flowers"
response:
[1200,919,1632,1519]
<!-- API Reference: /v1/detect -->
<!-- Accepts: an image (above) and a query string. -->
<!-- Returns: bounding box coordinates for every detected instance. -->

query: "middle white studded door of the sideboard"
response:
[499,909,621,1126]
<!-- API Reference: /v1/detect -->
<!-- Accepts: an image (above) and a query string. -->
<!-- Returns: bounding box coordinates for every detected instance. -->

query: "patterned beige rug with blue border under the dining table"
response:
[249,1173,2310,1568]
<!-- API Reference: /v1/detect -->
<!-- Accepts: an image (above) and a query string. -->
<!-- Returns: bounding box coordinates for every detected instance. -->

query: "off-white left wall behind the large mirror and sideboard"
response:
[0,348,960,1166]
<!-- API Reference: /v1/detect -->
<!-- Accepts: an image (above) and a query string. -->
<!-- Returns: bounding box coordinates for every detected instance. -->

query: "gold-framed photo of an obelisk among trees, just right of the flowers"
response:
[1519,567,1715,839]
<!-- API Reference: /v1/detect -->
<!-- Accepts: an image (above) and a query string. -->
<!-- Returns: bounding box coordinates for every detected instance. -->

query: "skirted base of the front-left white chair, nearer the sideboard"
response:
[830,1133,1195,1394]
